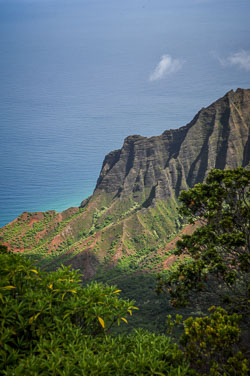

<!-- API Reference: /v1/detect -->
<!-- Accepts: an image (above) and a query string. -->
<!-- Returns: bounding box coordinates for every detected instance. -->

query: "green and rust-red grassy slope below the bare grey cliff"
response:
[0,194,181,278]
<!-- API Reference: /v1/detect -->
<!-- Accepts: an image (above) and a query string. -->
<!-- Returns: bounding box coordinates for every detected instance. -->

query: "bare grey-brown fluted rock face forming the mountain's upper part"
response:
[95,89,250,205]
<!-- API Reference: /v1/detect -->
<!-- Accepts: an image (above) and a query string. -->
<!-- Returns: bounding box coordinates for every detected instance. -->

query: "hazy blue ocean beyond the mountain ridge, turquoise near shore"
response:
[0,0,250,226]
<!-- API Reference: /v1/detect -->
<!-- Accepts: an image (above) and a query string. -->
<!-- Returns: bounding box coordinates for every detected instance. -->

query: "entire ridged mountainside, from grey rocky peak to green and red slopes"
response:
[0,89,250,278]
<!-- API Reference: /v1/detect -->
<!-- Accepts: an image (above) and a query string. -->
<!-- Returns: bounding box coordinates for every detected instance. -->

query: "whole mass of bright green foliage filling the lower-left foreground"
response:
[0,247,195,376]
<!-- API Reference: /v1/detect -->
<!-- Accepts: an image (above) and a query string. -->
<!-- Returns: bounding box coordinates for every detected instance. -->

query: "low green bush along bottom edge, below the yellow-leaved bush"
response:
[6,327,193,376]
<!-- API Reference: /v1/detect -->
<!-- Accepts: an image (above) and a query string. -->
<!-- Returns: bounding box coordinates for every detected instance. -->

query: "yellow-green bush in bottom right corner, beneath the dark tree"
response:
[181,307,250,376]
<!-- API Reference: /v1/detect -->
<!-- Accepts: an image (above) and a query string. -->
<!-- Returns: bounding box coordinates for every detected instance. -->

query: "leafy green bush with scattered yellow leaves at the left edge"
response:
[0,247,136,366]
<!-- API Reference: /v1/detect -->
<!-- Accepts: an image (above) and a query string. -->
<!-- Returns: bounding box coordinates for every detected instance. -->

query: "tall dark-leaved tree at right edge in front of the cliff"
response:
[158,168,250,313]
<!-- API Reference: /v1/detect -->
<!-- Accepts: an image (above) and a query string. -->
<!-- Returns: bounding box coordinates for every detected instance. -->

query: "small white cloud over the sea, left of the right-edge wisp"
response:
[149,55,183,81]
